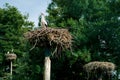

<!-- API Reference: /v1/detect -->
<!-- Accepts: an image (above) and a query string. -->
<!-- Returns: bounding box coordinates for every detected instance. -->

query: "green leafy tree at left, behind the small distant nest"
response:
[0,4,33,77]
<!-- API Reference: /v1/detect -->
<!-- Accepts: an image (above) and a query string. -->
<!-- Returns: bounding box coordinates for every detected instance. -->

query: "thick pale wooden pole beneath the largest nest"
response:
[44,56,51,80]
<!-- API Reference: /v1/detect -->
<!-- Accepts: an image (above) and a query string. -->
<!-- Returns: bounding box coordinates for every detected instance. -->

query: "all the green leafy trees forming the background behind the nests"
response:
[0,0,120,80]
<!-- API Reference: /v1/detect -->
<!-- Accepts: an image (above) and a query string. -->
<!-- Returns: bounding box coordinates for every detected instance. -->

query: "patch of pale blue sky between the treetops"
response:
[0,0,51,27]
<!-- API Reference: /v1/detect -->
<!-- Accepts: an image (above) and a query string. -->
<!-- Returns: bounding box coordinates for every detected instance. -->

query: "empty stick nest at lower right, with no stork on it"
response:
[84,61,115,73]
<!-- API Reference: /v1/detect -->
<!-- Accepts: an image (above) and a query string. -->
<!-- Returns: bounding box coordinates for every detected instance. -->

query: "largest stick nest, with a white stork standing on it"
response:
[25,27,72,49]
